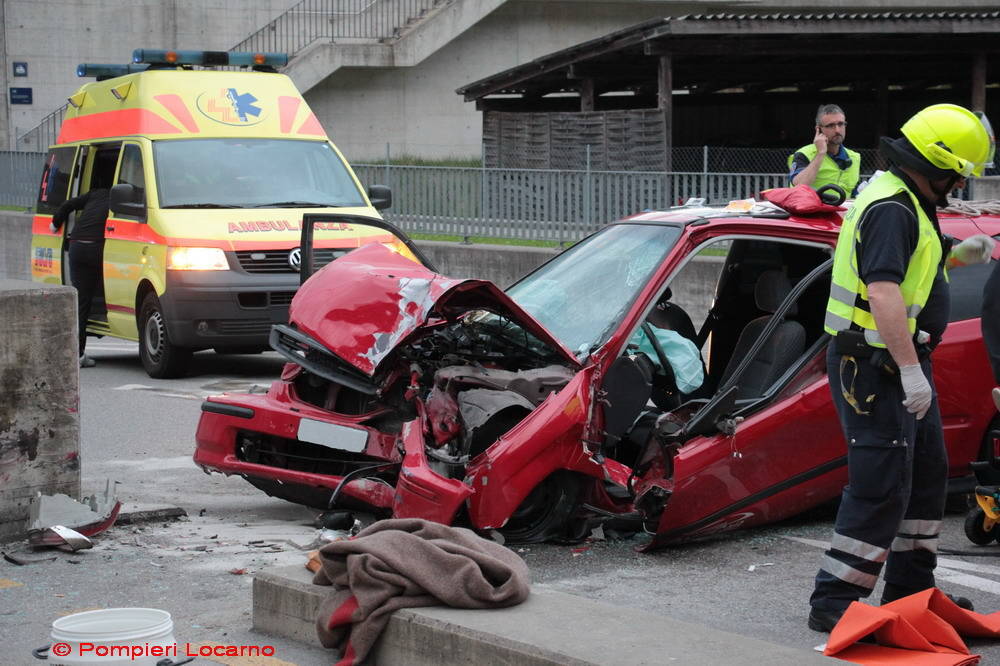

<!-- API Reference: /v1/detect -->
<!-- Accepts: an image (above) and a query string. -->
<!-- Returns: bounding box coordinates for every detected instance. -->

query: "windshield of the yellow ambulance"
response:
[153,139,365,208]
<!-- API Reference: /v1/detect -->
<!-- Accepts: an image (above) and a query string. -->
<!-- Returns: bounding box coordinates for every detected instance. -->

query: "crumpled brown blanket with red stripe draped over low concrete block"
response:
[313,518,529,666]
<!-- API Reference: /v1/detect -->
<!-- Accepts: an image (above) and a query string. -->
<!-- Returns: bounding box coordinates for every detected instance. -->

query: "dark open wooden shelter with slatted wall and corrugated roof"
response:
[457,11,1000,171]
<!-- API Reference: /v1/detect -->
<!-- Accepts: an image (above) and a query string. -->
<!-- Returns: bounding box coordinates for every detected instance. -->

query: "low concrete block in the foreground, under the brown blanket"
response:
[253,566,837,666]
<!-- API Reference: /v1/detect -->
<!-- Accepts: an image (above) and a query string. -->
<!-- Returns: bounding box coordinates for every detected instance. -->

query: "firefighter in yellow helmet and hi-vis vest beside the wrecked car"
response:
[808,104,994,631]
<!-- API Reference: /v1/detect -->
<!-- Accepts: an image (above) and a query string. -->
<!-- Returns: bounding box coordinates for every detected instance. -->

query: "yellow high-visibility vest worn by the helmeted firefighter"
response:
[823,172,943,347]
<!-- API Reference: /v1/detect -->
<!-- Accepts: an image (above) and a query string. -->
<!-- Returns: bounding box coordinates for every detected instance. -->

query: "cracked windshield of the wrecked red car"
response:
[507,224,680,359]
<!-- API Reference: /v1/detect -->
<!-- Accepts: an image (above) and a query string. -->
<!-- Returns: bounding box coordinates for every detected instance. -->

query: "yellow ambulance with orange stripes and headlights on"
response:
[31,49,394,377]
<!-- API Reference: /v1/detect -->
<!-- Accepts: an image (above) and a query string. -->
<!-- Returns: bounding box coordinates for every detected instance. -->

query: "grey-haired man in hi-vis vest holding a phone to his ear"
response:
[788,104,861,198]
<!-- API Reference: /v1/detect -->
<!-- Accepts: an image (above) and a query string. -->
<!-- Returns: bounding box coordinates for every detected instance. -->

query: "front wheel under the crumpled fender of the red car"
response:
[498,471,580,543]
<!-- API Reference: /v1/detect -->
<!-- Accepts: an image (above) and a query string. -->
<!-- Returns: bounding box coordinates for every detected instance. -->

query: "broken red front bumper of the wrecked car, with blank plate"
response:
[194,382,472,524]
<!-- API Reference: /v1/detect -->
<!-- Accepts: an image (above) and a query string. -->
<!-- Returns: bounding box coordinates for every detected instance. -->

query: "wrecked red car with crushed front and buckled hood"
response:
[194,204,1000,547]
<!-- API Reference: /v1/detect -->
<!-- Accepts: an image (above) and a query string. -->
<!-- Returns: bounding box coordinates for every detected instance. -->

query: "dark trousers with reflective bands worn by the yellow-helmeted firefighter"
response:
[809,344,948,611]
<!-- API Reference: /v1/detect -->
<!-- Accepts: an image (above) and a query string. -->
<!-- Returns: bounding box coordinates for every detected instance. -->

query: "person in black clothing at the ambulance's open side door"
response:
[49,187,110,368]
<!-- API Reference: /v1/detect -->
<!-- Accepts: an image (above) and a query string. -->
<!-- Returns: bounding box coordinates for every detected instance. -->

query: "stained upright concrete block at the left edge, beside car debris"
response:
[0,279,80,541]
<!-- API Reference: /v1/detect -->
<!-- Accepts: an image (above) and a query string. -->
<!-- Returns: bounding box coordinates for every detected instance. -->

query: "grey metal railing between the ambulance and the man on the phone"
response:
[354,164,788,242]
